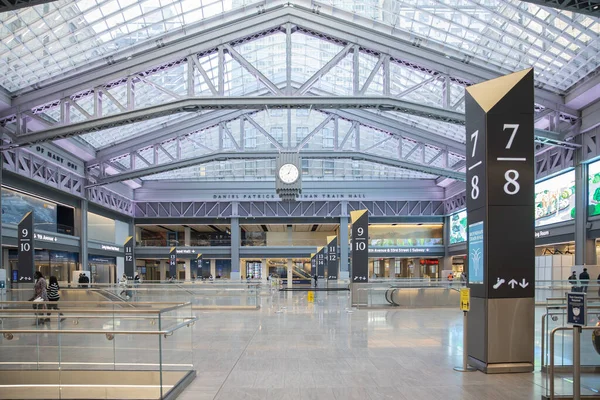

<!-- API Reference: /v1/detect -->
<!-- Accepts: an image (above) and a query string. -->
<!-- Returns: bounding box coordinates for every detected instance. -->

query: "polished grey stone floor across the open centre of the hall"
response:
[179,292,596,400]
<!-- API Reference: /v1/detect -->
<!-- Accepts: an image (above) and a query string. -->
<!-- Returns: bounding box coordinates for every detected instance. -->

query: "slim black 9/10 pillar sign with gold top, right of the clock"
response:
[350,210,369,283]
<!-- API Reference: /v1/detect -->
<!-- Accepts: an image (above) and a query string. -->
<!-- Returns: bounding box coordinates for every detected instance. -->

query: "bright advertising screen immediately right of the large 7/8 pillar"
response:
[535,171,575,226]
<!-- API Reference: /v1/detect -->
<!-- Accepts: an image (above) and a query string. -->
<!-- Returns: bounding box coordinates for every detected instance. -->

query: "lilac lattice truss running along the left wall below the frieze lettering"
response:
[2,148,133,216]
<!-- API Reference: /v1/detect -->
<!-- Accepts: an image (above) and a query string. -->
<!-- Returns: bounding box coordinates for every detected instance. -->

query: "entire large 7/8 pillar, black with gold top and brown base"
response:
[465,69,535,373]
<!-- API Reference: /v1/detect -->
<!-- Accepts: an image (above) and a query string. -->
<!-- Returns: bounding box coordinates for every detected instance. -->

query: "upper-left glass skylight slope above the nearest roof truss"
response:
[0,0,264,92]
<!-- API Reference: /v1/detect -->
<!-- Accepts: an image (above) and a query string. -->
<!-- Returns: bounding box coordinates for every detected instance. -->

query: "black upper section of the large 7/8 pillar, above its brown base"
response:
[465,70,535,298]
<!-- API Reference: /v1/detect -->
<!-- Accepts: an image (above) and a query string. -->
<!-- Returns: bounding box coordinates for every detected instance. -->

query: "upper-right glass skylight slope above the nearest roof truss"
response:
[321,0,600,90]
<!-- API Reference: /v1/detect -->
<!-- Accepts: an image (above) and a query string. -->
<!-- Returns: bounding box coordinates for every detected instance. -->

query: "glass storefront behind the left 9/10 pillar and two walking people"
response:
[8,249,79,284]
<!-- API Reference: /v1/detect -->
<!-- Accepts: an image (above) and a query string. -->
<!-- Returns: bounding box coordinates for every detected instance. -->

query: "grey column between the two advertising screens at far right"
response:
[574,147,596,265]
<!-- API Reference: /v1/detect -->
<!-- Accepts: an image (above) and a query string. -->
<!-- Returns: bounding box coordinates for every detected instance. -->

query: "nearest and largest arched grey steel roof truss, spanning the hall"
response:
[0,7,578,150]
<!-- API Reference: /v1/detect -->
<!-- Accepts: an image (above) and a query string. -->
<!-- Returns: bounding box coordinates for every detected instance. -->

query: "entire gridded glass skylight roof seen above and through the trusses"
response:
[0,0,600,184]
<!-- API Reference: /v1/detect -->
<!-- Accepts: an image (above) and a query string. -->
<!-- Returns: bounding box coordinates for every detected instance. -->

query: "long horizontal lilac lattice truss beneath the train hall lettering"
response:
[134,201,444,218]
